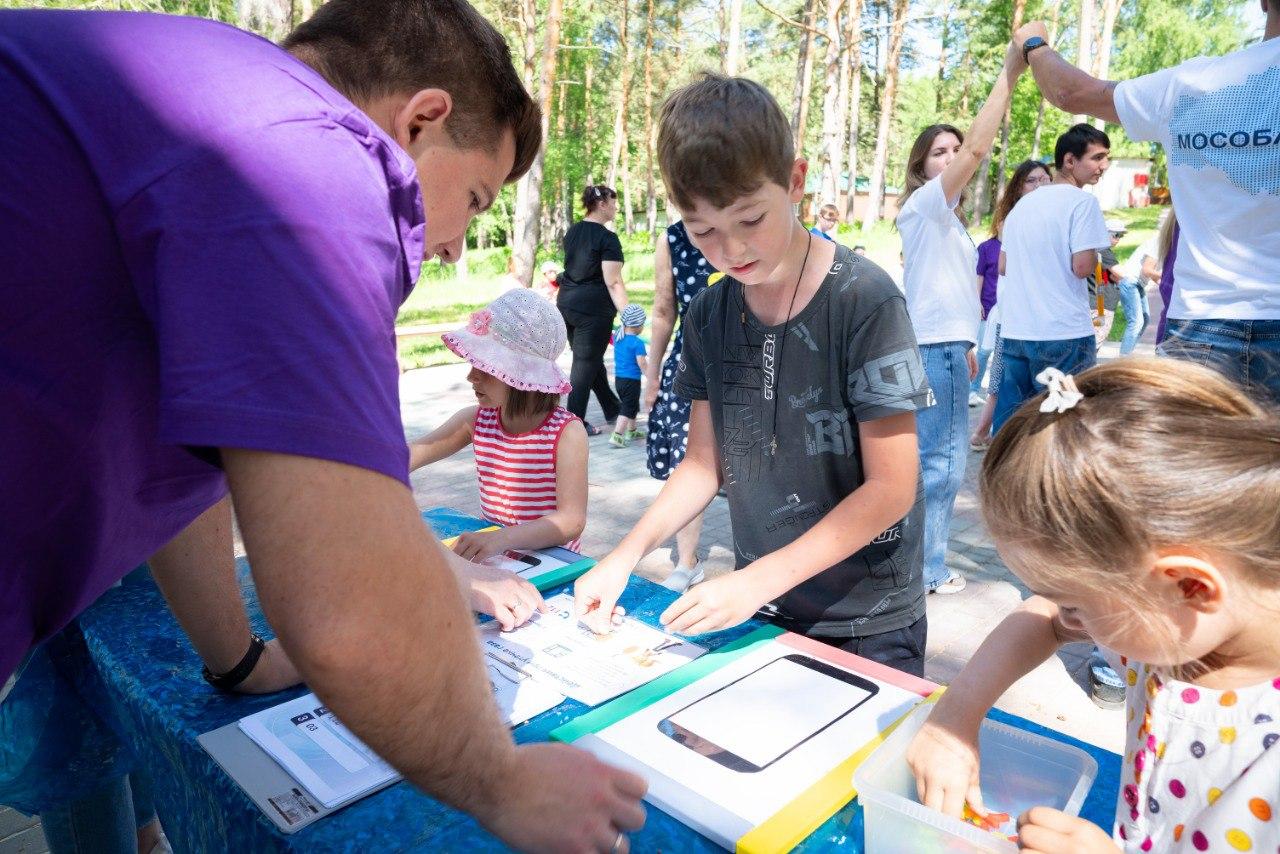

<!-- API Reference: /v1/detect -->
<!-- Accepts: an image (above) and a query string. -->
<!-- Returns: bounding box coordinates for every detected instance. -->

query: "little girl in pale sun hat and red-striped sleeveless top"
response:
[410,289,588,622]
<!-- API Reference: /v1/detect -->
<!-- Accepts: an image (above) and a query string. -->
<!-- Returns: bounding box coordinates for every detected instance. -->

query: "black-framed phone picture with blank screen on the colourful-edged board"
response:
[658,654,878,772]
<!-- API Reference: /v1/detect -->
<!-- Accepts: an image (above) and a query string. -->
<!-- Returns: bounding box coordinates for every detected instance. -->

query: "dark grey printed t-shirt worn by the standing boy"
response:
[675,246,933,638]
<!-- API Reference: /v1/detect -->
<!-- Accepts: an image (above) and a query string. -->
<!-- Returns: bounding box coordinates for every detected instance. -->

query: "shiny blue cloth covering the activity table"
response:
[81,510,1120,853]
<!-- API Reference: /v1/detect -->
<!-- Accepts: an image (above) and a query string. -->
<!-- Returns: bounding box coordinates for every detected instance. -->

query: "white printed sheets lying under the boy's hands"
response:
[480,593,707,705]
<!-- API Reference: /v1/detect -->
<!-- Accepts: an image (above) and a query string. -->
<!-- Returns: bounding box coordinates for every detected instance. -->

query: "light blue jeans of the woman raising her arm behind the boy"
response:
[915,341,969,590]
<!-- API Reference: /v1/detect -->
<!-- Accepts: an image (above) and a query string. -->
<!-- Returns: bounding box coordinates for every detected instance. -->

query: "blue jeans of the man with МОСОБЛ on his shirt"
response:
[1160,319,1280,405]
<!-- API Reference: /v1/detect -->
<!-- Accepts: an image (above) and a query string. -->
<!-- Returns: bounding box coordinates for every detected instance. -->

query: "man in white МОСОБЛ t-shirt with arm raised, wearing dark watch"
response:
[1014,0,1280,399]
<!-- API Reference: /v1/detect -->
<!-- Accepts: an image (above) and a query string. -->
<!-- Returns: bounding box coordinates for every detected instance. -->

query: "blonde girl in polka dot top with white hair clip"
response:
[908,359,1280,854]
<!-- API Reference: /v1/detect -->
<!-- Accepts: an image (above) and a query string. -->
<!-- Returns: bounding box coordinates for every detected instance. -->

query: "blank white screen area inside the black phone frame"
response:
[669,658,868,768]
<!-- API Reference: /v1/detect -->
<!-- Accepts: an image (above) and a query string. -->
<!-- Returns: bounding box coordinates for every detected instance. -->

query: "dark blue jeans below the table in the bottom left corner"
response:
[40,772,156,854]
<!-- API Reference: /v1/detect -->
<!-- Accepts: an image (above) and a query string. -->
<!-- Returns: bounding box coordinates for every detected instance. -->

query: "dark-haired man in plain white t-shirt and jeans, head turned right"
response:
[992,124,1111,431]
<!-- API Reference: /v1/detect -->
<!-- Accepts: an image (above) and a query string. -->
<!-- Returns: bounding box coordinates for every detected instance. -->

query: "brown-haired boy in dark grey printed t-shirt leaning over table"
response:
[575,76,932,675]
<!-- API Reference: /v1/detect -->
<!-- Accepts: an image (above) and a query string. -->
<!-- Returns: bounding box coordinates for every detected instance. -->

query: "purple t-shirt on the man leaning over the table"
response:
[0,10,424,682]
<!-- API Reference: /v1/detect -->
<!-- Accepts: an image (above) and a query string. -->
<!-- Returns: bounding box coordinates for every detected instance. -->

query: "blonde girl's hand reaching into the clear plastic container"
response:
[906,697,987,818]
